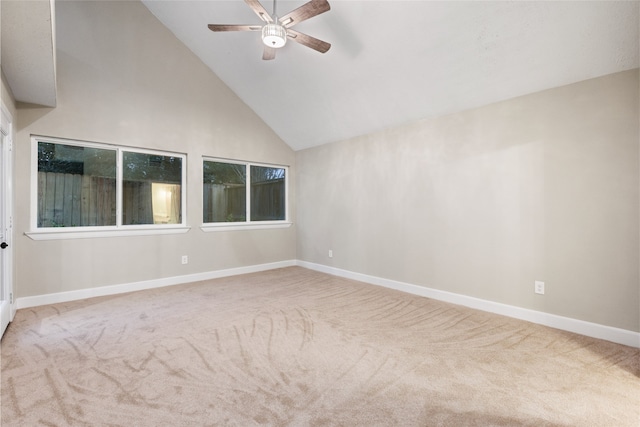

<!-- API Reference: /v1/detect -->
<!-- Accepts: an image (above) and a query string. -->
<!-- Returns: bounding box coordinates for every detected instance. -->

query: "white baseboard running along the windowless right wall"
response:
[296,260,640,348]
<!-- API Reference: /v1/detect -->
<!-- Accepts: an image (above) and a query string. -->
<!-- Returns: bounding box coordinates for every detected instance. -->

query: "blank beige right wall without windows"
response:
[296,69,640,331]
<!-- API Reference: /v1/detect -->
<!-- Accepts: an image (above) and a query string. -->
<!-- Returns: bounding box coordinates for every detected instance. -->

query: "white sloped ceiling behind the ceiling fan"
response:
[143,0,639,150]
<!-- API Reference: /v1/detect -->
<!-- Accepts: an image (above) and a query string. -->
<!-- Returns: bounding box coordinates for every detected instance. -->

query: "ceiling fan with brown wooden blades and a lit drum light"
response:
[208,0,331,60]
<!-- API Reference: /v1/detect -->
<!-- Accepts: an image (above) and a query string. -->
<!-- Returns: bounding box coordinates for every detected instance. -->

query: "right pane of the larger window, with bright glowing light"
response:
[122,151,182,225]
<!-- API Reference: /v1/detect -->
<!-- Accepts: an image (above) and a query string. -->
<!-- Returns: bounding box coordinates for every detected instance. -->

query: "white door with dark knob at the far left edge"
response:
[0,108,15,336]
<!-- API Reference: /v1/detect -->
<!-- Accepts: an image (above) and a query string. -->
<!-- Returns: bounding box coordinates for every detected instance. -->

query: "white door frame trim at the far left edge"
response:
[0,102,16,336]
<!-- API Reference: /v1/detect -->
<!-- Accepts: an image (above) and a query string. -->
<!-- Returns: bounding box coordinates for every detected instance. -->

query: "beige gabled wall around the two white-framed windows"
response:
[15,1,296,297]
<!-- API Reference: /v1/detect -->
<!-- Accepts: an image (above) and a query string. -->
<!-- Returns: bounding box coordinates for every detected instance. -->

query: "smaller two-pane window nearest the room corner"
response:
[203,159,288,225]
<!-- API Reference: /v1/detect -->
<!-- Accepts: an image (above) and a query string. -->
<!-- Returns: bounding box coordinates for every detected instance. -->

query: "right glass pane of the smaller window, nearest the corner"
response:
[251,166,285,221]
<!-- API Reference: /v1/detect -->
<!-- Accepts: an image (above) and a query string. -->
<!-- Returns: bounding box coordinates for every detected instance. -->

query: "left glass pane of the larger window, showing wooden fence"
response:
[37,142,116,227]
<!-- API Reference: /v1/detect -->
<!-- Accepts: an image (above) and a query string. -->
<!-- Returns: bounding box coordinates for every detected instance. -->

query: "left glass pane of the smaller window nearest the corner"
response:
[203,160,247,223]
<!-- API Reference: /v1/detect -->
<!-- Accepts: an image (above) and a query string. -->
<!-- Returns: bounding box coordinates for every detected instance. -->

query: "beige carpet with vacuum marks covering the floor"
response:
[1,267,640,427]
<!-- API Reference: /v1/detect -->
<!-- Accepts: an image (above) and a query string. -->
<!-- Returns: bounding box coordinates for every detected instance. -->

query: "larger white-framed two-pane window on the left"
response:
[32,137,186,237]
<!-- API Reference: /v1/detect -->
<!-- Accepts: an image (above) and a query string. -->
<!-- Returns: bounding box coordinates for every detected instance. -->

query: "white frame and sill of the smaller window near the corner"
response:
[200,156,292,232]
